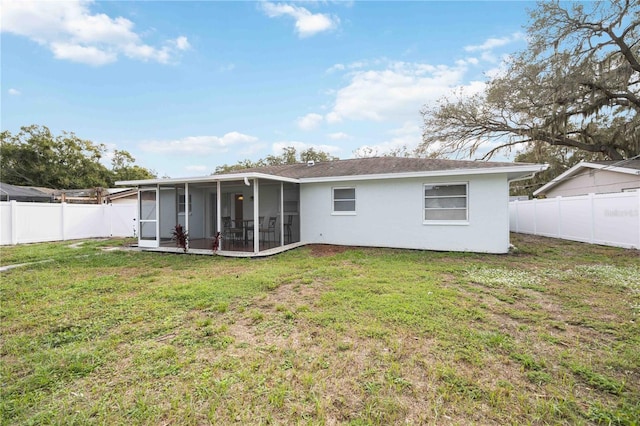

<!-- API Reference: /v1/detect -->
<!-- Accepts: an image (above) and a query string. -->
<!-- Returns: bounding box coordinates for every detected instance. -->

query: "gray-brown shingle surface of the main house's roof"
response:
[221,157,525,179]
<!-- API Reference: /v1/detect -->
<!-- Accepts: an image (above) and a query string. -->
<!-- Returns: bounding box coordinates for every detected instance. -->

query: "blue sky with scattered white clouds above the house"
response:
[0,0,535,177]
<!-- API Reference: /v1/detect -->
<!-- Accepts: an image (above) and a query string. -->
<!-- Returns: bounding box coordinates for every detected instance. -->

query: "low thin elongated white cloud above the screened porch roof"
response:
[140,132,258,155]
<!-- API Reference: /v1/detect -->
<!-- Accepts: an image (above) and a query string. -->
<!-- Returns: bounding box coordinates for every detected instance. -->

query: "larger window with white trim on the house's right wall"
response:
[424,183,469,223]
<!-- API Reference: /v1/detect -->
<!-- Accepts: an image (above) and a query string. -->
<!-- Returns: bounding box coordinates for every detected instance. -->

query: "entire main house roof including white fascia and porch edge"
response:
[116,157,547,185]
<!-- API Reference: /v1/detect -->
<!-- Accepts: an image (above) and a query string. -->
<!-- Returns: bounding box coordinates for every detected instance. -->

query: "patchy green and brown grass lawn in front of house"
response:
[0,235,640,425]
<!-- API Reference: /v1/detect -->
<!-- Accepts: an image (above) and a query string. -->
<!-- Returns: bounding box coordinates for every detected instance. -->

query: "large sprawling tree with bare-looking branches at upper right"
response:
[420,0,640,160]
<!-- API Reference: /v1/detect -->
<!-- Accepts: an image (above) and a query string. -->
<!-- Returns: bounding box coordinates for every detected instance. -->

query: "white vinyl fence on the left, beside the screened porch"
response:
[0,201,138,245]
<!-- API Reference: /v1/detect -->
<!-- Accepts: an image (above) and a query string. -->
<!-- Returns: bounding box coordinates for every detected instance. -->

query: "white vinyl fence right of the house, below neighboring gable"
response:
[509,191,640,249]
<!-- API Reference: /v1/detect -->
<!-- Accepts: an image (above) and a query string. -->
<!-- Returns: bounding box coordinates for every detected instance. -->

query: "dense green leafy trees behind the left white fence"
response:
[0,125,153,189]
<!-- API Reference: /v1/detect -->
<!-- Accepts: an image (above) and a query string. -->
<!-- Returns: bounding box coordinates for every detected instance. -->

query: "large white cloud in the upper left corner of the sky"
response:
[2,0,190,66]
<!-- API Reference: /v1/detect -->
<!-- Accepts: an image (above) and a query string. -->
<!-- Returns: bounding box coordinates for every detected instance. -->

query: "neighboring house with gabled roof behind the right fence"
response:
[533,160,640,198]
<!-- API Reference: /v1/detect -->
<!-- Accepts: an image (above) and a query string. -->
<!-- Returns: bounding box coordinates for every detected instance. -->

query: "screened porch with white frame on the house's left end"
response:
[131,173,300,256]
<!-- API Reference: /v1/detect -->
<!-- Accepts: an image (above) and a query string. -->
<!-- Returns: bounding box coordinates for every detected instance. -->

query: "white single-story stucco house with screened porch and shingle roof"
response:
[118,157,547,256]
